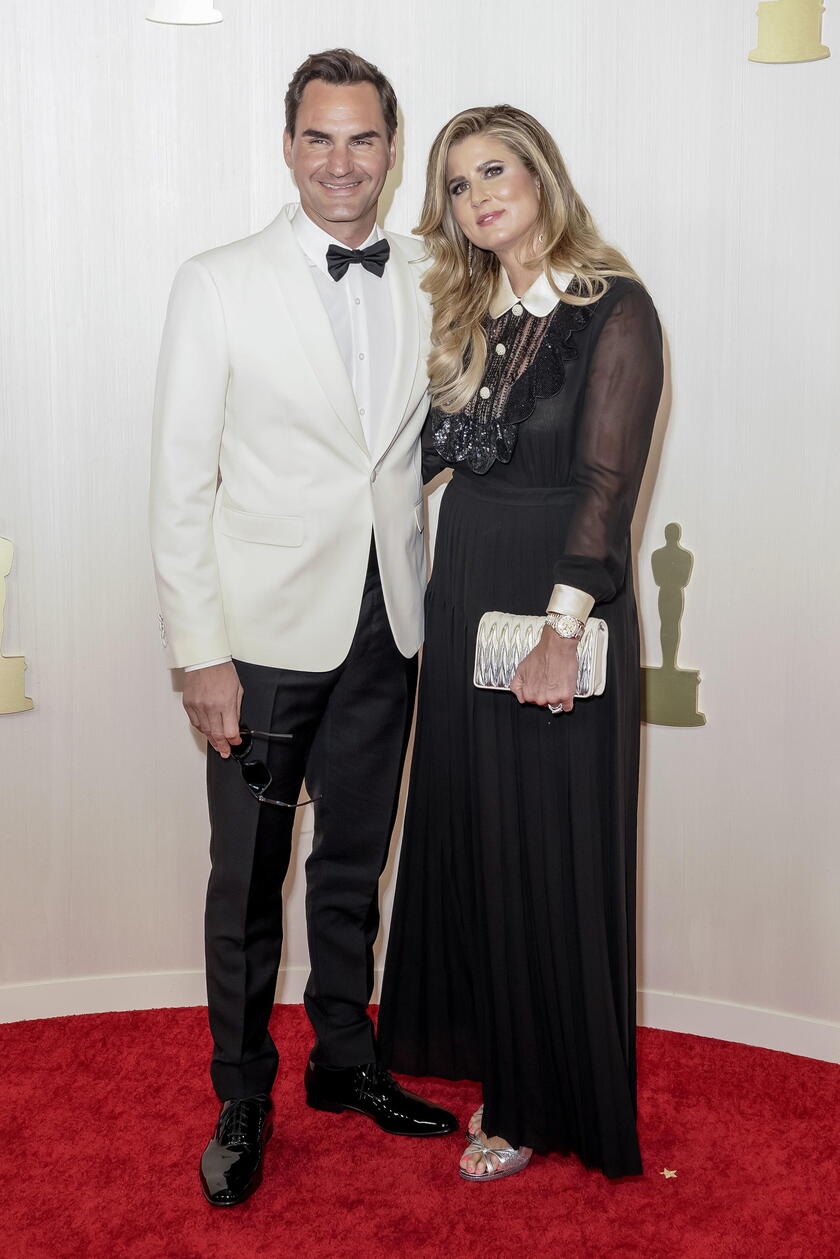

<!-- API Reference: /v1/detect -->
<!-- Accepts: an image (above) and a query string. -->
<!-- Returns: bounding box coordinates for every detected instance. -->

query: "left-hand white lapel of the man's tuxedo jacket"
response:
[261,205,367,454]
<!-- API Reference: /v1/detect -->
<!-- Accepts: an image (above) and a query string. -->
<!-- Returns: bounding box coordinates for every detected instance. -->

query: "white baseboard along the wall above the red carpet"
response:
[0,966,840,1063]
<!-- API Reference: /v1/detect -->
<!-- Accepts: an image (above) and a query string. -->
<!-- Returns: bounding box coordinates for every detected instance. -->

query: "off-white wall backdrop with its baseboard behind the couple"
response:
[0,0,840,1060]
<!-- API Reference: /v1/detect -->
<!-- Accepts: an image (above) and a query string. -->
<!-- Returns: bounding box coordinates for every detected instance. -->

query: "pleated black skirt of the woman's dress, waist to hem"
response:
[379,472,641,1177]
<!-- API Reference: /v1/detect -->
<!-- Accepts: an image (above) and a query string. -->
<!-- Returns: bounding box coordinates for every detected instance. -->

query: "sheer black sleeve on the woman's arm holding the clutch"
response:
[554,283,662,603]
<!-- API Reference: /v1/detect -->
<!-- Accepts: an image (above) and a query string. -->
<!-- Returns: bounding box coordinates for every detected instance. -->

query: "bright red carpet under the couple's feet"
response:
[0,1006,840,1259]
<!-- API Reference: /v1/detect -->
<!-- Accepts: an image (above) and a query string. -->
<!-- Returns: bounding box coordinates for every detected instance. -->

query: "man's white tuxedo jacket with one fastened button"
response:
[150,205,429,672]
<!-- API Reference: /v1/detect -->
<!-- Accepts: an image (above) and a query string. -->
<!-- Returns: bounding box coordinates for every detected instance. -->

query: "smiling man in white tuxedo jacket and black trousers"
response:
[151,49,456,1206]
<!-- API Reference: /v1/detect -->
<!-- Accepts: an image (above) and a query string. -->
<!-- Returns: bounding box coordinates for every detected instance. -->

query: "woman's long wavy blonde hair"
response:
[414,104,639,413]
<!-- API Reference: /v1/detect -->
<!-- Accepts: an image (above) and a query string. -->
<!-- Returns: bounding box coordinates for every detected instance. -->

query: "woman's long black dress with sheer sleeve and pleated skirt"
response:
[379,278,662,1176]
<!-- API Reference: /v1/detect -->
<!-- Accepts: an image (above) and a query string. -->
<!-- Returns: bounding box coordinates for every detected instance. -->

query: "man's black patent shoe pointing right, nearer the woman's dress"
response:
[304,1060,458,1137]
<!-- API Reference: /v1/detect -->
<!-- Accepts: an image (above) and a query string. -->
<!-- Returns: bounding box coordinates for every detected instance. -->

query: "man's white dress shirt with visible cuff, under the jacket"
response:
[185,206,395,674]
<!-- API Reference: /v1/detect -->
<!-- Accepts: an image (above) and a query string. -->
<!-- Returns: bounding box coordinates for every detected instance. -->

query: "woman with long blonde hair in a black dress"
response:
[379,106,662,1181]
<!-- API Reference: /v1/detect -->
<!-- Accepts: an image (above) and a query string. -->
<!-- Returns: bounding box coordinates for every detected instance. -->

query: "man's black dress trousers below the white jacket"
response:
[205,546,417,1100]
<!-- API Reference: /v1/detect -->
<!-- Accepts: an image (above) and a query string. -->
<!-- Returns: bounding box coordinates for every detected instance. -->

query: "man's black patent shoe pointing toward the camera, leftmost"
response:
[199,1093,271,1206]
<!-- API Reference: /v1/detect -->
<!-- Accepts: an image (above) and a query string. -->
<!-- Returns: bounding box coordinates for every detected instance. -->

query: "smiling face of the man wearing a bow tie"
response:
[283,79,397,246]
